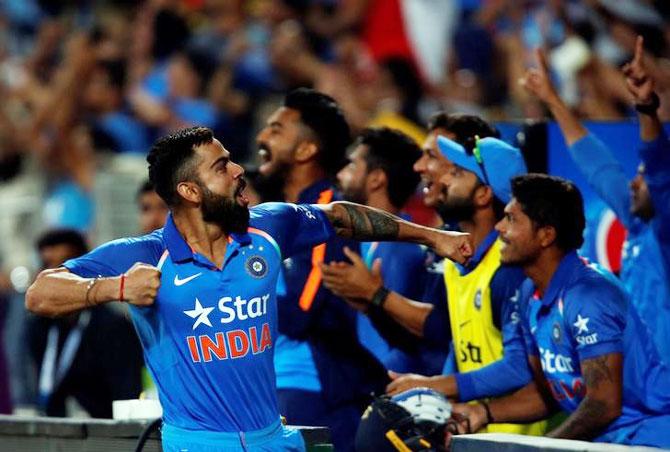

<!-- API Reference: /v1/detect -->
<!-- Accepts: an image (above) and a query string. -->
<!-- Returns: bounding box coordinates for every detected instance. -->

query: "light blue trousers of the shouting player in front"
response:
[161,420,305,452]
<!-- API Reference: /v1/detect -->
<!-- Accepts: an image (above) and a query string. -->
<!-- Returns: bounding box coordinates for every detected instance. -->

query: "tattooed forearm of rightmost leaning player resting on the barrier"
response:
[547,395,618,440]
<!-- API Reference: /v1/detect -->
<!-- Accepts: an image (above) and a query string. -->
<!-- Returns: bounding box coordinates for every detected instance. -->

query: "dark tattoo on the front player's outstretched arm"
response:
[331,203,400,241]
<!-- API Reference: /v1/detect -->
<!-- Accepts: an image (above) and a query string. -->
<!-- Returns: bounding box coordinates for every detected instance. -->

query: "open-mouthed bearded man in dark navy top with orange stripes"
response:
[257,88,386,450]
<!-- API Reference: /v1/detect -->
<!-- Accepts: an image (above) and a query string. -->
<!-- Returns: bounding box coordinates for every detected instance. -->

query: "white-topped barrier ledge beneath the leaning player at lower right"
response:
[451,432,670,452]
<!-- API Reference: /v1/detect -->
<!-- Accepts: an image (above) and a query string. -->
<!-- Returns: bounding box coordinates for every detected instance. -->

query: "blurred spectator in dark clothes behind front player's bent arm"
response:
[26,229,143,418]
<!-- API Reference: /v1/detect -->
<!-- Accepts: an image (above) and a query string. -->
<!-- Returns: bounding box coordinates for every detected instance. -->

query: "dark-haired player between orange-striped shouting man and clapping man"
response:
[337,127,447,375]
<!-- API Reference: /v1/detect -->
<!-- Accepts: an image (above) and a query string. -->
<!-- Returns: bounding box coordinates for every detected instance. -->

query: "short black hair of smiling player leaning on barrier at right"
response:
[512,173,586,252]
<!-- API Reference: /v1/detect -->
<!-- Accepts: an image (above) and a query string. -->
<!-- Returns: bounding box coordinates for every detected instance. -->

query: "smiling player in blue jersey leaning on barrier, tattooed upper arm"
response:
[455,174,670,447]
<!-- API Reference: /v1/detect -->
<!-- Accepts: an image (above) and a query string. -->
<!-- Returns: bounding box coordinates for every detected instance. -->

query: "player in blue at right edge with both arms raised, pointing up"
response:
[523,37,670,363]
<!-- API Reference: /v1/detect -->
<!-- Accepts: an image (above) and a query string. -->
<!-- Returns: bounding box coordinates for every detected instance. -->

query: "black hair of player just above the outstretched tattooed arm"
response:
[356,127,421,208]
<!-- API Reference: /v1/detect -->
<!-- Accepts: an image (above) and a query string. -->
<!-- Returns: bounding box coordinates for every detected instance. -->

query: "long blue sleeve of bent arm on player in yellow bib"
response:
[455,267,531,401]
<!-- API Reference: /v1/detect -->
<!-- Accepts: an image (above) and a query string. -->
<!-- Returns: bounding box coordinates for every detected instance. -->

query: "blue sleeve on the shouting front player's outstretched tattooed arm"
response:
[250,202,335,258]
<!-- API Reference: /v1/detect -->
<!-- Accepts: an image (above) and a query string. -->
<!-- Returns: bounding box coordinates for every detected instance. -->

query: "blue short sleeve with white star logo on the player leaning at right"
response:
[563,270,627,360]
